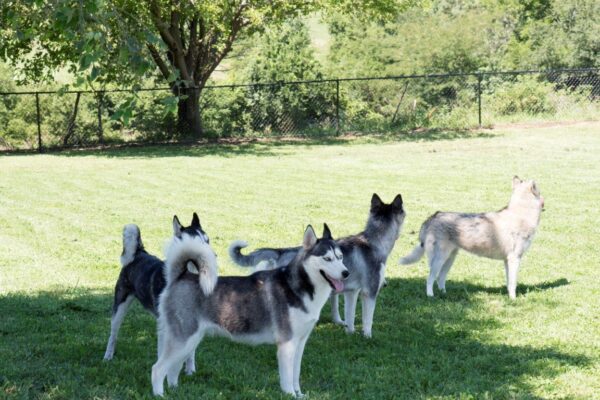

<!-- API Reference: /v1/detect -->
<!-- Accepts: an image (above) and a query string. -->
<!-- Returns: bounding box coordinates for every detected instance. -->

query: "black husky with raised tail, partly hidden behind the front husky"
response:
[104,213,209,374]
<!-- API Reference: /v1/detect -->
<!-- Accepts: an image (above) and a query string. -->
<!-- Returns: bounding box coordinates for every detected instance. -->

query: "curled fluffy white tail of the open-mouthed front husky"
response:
[165,236,218,296]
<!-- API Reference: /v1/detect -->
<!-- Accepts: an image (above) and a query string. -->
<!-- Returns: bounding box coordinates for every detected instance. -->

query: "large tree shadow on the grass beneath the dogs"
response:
[0,279,590,399]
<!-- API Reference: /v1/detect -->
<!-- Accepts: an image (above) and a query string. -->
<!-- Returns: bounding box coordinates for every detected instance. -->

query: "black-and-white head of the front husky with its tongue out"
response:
[303,224,349,293]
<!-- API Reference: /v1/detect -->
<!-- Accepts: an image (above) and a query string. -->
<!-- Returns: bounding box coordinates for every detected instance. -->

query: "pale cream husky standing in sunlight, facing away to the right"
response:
[400,176,544,299]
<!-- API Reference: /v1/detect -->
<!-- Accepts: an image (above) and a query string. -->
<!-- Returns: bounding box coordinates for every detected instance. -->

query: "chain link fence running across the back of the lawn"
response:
[0,69,600,151]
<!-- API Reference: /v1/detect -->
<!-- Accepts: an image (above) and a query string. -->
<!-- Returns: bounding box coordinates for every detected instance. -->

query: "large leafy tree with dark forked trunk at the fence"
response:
[0,0,408,136]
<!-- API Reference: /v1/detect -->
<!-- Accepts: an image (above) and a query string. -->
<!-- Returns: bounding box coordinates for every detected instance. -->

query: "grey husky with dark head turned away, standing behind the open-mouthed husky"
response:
[229,194,406,337]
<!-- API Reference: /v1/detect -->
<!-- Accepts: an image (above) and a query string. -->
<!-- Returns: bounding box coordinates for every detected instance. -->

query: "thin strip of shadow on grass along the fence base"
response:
[0,129,498,158]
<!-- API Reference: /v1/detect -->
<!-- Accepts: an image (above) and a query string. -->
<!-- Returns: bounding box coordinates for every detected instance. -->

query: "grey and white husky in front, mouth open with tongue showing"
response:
[152,225,348,396]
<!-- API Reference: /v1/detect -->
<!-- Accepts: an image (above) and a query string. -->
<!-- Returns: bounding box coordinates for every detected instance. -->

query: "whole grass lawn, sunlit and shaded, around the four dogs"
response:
[0,123,600,399]
